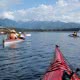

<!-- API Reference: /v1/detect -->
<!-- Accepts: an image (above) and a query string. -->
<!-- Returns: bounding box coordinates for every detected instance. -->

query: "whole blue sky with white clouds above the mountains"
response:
[0,0,80,23]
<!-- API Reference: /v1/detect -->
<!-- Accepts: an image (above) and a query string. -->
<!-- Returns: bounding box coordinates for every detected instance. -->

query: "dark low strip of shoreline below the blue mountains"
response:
[0,28,80,32]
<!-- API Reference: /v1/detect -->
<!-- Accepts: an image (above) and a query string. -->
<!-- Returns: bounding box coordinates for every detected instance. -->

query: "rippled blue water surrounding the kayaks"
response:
[0,32,80,80]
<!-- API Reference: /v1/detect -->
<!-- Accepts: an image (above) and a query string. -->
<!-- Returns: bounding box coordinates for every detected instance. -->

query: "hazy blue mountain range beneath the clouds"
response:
[0,19,80,29]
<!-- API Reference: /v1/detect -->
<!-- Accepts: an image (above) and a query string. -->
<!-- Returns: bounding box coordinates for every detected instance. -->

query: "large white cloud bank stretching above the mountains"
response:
[2,0,80,22]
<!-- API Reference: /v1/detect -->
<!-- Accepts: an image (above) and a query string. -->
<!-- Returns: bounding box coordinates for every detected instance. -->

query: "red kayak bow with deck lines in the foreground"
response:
[42,46,80,80]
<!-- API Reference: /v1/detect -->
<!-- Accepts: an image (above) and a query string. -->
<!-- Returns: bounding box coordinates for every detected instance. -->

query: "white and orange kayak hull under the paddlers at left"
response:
[3,39,24,47]
